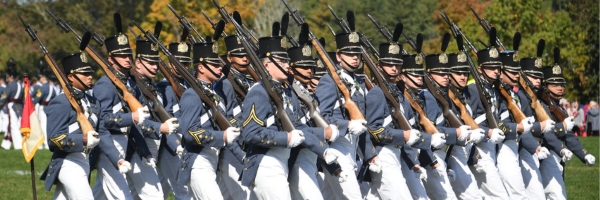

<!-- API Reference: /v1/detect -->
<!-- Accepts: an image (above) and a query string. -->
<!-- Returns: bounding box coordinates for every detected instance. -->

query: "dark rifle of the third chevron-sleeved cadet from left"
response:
[226,11,295,132]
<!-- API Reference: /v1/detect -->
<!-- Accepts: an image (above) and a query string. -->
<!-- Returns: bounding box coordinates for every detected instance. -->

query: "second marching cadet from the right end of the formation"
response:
[518,39,563,199]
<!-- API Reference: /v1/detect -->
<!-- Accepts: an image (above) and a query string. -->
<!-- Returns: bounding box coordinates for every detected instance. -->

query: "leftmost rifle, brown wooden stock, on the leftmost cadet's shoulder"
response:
[17,14,94,142]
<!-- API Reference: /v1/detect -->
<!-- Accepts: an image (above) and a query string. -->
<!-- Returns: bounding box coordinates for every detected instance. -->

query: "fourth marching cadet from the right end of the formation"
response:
[465,28,533,199]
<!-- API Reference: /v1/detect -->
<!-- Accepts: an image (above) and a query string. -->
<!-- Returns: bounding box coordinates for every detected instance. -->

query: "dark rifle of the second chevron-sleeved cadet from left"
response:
[131,20,231,130]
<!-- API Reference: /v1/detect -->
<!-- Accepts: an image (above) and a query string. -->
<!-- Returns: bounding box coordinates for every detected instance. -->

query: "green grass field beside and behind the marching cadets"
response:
[0,137,600,200]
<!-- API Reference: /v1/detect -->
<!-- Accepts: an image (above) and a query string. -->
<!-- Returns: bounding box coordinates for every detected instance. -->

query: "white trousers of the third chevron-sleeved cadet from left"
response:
[250,147,292,200]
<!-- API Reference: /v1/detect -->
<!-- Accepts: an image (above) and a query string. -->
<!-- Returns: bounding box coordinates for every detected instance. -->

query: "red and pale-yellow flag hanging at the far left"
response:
[21,77,45,162]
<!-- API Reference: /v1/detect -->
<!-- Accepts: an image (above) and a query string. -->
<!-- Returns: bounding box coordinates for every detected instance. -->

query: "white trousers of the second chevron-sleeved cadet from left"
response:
[188,147,223,200]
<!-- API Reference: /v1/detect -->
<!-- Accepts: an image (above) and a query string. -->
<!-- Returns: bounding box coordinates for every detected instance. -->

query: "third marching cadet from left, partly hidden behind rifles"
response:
[127,39,179,199]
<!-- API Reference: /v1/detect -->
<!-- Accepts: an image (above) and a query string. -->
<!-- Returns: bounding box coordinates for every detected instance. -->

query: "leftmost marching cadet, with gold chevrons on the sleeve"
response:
[41,53,101,199]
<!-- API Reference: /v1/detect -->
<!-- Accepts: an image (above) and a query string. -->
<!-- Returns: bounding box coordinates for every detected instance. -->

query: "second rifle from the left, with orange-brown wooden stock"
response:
[46,9,143,111]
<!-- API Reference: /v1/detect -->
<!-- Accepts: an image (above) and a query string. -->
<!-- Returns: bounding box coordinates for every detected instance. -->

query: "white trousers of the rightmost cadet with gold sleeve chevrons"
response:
[370,145,412,199]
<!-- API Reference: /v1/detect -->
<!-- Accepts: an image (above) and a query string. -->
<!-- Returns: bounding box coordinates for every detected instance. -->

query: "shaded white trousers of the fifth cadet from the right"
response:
[448,143,482,200]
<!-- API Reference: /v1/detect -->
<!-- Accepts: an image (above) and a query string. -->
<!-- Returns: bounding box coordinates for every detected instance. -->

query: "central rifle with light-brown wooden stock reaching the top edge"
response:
[282,0,365,120]
